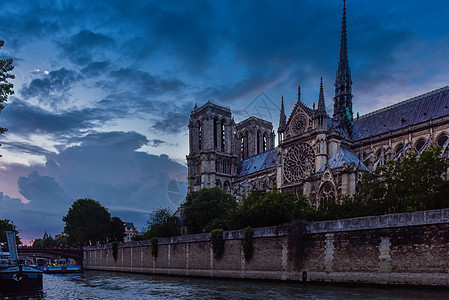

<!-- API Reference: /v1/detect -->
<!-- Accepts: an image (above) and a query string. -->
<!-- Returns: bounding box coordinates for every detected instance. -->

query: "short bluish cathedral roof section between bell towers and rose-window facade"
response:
[237,148,278,177]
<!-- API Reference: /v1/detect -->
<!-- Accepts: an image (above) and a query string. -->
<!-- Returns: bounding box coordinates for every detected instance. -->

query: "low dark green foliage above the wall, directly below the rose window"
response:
[230,190,309,229]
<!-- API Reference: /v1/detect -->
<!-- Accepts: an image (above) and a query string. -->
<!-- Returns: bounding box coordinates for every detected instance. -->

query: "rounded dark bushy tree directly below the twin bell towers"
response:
[184,187,237,233]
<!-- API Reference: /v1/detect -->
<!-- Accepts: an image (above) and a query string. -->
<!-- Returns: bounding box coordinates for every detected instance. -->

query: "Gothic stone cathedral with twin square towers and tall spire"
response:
[187,0,449,206]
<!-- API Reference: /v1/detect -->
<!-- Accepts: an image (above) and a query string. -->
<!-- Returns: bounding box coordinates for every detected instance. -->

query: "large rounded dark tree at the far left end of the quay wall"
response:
[62,198,125,246]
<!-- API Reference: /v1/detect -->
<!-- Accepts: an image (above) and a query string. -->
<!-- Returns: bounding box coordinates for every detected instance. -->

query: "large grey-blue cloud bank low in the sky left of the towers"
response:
[0,132,187,238]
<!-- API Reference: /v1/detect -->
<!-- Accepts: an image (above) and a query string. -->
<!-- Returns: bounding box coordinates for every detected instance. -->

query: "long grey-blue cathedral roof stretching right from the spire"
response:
[354,86,449,141]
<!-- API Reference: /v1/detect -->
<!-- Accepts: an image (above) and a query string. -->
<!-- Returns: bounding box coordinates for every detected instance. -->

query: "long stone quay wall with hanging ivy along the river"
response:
[83,209,449,287]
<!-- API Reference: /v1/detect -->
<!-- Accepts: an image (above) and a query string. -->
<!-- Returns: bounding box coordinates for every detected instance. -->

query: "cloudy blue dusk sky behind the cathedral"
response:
[0,0,449,243]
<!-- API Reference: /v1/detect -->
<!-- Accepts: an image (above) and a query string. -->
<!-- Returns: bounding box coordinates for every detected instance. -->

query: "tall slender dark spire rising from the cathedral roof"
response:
[332,0,353,139]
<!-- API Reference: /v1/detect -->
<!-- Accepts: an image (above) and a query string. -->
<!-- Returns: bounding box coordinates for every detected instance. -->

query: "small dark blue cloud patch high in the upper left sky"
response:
[60,29,115,66]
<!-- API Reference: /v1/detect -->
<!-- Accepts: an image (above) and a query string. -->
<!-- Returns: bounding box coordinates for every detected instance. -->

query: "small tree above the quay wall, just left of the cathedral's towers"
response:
[134,208,180,240]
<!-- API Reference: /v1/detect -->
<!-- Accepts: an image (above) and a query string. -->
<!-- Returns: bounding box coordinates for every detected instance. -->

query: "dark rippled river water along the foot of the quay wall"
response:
[0,271,449,300]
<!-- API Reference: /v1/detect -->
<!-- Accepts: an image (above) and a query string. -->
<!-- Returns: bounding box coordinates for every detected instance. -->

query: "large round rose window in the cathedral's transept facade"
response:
[284,143,315,182]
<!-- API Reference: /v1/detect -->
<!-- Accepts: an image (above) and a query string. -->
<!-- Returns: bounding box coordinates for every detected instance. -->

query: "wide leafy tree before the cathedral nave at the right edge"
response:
[358,146,449,214]
